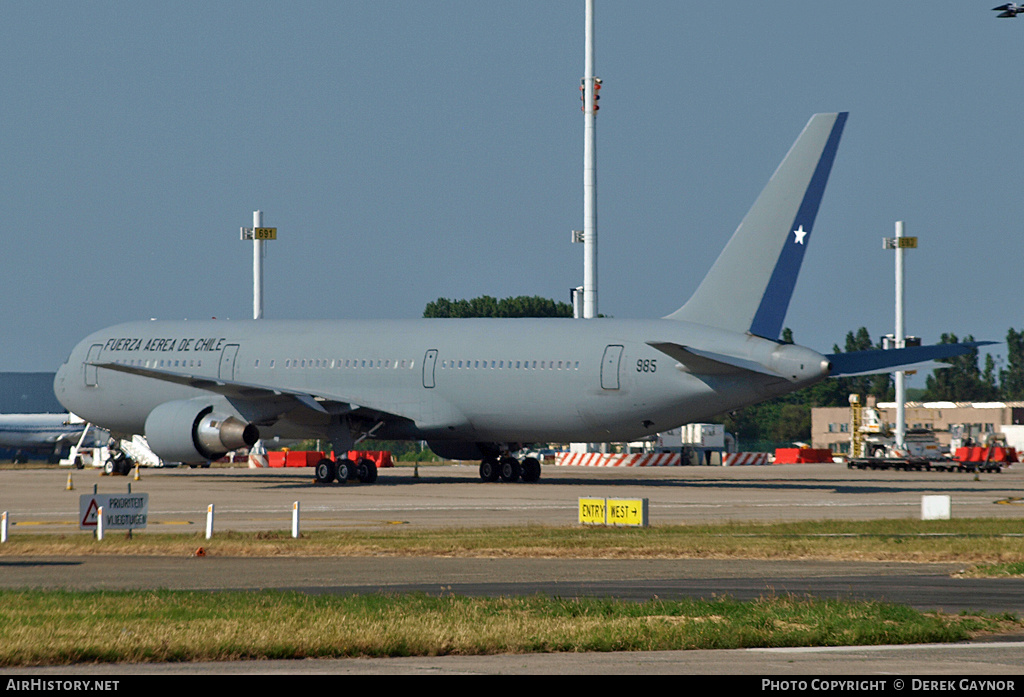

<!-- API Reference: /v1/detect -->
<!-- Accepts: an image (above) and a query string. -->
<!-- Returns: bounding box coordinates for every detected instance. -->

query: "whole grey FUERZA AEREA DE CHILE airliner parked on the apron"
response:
[54,113,972,482]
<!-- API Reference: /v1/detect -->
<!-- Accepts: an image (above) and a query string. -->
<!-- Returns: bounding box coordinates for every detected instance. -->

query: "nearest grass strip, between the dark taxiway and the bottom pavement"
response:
[0,591,1022,666]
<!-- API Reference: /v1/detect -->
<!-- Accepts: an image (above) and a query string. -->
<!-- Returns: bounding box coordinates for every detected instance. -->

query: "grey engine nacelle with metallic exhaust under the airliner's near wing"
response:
[145,399,259,465]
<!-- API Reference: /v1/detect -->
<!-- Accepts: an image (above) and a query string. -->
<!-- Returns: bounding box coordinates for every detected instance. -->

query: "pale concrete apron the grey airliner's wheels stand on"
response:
[6,458,1024,534]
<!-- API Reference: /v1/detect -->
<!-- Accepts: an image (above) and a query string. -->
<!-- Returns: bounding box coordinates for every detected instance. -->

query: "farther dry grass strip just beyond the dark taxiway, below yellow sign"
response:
[0,519,1024,574]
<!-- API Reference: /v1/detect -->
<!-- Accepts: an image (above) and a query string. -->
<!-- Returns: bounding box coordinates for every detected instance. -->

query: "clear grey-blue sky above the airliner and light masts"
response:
[0,0,1024,386]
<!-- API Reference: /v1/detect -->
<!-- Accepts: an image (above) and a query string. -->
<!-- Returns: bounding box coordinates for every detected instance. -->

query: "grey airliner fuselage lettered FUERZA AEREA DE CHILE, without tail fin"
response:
[54,319,827,450]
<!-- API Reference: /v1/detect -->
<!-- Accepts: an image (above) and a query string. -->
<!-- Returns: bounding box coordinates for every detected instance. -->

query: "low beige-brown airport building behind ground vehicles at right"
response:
[811,401,1024,454]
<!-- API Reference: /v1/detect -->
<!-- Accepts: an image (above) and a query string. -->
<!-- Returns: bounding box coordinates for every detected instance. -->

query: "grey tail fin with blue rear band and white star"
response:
[666,112,847,341]
